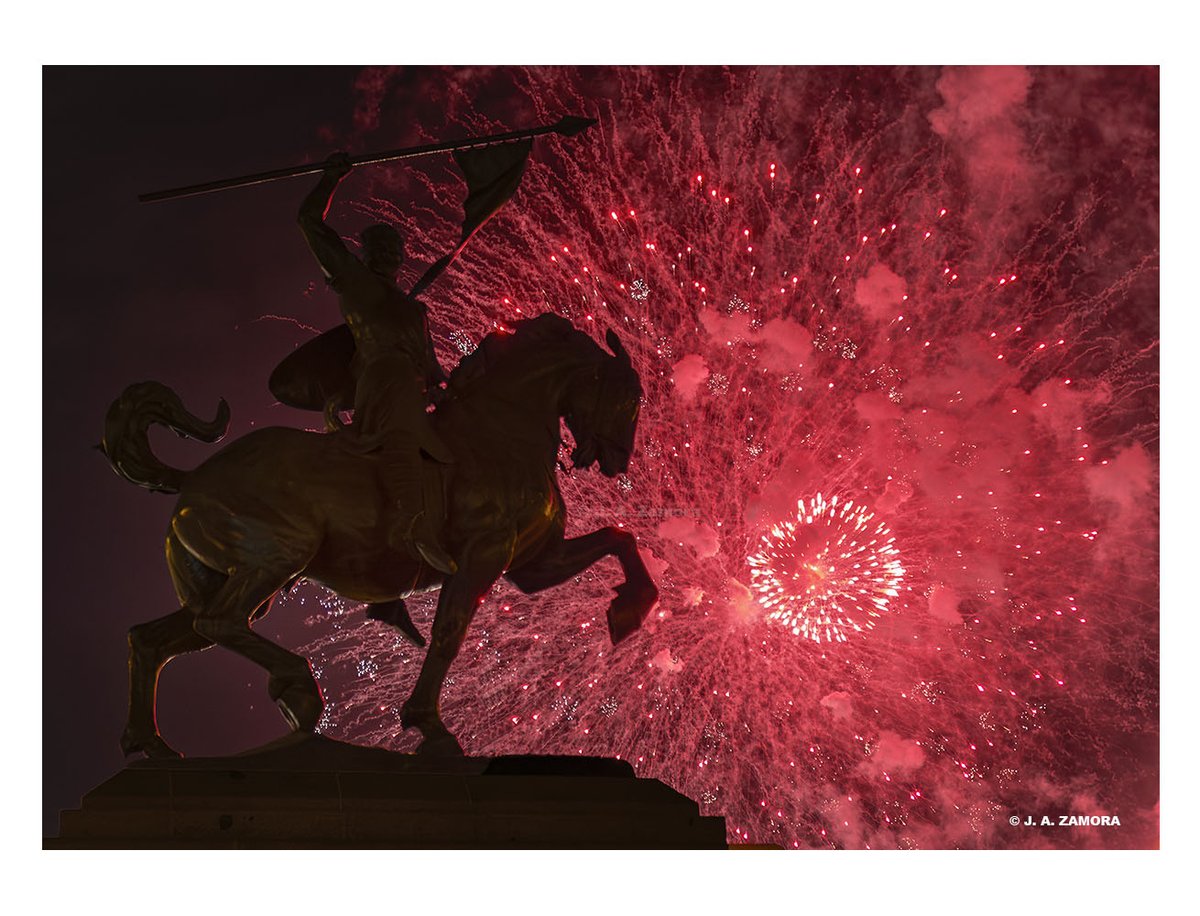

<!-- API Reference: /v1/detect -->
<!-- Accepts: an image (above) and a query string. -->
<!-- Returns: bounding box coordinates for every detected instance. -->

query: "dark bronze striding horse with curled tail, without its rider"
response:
[101,315,658,756]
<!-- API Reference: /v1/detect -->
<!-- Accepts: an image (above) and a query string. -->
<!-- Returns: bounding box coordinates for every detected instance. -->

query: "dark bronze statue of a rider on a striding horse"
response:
[108,118,658,758]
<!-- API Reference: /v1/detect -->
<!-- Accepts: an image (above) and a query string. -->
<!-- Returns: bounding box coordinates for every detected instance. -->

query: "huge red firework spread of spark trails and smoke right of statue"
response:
[276,68,1158,848]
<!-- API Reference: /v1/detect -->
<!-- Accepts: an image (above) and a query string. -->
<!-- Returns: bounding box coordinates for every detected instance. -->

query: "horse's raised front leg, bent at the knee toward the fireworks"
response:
[508,528,659,643]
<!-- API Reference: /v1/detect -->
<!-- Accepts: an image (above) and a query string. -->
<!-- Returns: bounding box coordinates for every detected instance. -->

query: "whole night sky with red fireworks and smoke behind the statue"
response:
[43,67,1159,869]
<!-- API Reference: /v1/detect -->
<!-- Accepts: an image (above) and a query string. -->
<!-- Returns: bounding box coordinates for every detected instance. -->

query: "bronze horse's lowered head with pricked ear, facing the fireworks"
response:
[564,331,642,477]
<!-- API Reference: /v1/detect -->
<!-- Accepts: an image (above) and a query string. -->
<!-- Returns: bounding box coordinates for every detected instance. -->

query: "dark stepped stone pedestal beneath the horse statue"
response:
[44,735,726,849]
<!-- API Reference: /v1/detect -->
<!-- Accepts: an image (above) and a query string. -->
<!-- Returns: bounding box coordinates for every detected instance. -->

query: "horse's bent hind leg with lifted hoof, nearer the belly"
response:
[192,569,325,731]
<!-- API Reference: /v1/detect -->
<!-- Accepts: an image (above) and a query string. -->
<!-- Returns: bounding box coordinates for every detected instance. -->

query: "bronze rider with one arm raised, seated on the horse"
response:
[300,154,457,574]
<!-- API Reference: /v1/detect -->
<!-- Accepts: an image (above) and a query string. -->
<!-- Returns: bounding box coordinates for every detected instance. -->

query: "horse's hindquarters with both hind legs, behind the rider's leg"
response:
[115,424,436,756]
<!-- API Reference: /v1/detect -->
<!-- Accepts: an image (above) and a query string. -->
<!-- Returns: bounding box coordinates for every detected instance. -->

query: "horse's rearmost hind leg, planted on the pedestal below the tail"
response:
[121,607,212,758]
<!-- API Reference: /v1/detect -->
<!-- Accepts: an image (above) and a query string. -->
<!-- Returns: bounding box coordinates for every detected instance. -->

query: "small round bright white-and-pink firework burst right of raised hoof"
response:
[748,493,904,642]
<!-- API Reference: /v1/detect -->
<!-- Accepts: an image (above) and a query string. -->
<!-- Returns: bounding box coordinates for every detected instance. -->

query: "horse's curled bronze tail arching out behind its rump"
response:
[100,382,229,493]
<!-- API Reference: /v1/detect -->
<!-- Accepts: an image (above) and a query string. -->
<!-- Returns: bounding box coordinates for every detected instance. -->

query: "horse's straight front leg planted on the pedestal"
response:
[400,537,514,756]
